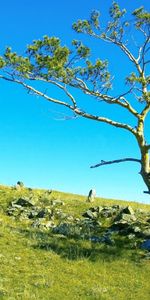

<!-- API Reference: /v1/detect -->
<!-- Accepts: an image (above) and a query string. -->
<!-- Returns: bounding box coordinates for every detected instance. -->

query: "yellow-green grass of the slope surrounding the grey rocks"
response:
[0,186,150,300]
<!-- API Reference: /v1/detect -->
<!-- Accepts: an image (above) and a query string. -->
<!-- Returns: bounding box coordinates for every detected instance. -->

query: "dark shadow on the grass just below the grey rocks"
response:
[21,230,138,262]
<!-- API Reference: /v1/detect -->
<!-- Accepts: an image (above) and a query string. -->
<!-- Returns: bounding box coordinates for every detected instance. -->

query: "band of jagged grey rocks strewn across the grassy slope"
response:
[7,197,150,251]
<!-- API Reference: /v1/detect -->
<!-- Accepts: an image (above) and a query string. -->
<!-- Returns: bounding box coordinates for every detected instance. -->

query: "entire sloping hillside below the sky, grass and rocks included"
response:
[0,186,150,300]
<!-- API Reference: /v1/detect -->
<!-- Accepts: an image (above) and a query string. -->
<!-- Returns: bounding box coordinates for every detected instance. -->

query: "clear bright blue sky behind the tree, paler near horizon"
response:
[0,0,150,203]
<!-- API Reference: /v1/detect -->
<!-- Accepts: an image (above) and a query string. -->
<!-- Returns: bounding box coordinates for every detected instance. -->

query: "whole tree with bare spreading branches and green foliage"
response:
[0,2,150,194]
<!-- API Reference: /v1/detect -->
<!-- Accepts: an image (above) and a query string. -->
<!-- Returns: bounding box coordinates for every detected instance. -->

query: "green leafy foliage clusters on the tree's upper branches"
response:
[0,2,150,99]
